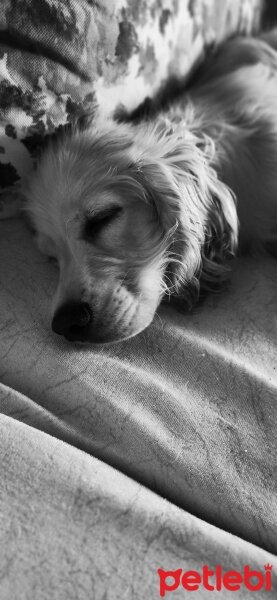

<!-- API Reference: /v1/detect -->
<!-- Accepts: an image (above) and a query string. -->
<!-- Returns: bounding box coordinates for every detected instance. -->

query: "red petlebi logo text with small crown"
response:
[158,564,272,597]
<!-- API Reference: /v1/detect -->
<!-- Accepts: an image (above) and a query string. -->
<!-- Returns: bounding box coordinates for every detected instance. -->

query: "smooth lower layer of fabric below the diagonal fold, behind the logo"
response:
[0,410,277,600]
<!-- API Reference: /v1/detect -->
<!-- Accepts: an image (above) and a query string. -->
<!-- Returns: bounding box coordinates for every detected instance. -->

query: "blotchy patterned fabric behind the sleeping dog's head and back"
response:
[0,0,262,218]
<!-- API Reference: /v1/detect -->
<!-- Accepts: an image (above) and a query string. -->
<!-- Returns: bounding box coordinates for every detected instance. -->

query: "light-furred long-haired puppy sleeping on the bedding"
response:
[27,31,277,343]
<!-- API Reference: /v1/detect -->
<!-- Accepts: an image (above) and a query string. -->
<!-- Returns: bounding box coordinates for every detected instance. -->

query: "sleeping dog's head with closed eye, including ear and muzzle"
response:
[27,118,236,343]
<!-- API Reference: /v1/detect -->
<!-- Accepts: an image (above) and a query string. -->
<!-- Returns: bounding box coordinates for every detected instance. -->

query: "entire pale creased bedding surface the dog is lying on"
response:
[0,220,277,600]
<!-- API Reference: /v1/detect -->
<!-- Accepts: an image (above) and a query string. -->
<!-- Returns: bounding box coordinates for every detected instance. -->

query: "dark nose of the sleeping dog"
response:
[52,302,92,342]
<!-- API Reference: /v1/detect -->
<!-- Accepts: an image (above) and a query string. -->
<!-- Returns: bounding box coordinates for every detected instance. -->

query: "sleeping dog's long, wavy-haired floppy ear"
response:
[129,123,238,305]
